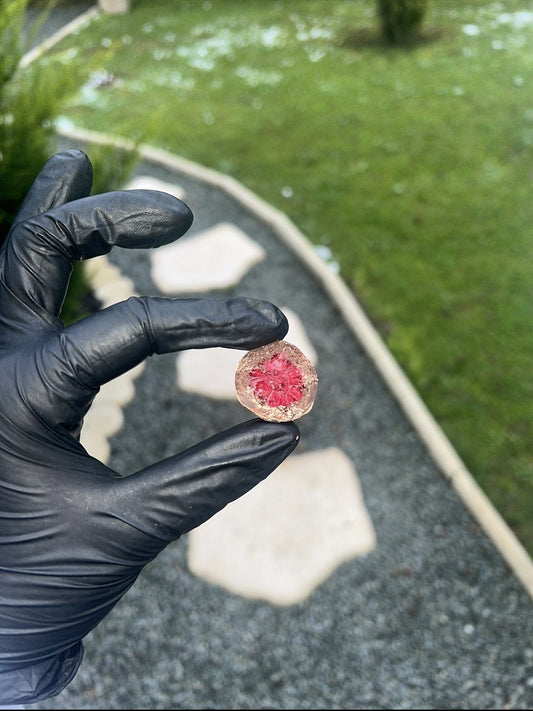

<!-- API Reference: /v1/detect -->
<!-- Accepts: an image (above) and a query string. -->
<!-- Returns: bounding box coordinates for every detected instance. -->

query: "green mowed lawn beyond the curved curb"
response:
[40,0,533,553]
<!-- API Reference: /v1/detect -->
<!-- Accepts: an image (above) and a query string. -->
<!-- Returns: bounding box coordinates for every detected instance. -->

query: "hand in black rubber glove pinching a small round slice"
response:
[0,150,299,705]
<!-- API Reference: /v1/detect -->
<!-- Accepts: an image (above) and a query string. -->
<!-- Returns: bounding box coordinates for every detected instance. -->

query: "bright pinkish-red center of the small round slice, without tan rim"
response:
[250,353,304,407]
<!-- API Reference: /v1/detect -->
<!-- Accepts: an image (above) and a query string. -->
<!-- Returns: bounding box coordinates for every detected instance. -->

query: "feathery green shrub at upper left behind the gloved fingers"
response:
[0,0,138,323]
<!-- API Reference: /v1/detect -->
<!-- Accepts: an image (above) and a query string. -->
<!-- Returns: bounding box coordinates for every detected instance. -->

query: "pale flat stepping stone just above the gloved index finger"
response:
[151,222,266,294]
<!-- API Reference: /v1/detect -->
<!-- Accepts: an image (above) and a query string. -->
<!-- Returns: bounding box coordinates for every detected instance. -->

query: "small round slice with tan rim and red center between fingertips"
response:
[235,341,318,422]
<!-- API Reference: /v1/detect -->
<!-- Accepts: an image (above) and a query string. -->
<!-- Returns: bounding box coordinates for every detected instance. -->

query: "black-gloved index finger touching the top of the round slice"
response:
[33,296,288,424]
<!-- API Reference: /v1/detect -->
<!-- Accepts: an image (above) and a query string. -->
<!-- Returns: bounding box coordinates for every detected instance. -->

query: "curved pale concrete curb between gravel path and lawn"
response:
[58,129,533,599]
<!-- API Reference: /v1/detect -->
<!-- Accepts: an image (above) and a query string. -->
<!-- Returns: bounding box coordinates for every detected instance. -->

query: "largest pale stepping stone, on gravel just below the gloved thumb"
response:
[188,447,376,605]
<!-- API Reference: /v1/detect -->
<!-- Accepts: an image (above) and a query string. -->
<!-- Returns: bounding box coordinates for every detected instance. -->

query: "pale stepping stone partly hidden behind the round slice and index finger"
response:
[176,308,318,400]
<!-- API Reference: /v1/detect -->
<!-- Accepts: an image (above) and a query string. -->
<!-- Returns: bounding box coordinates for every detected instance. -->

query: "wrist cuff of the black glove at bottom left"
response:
[0,642,83,706]
